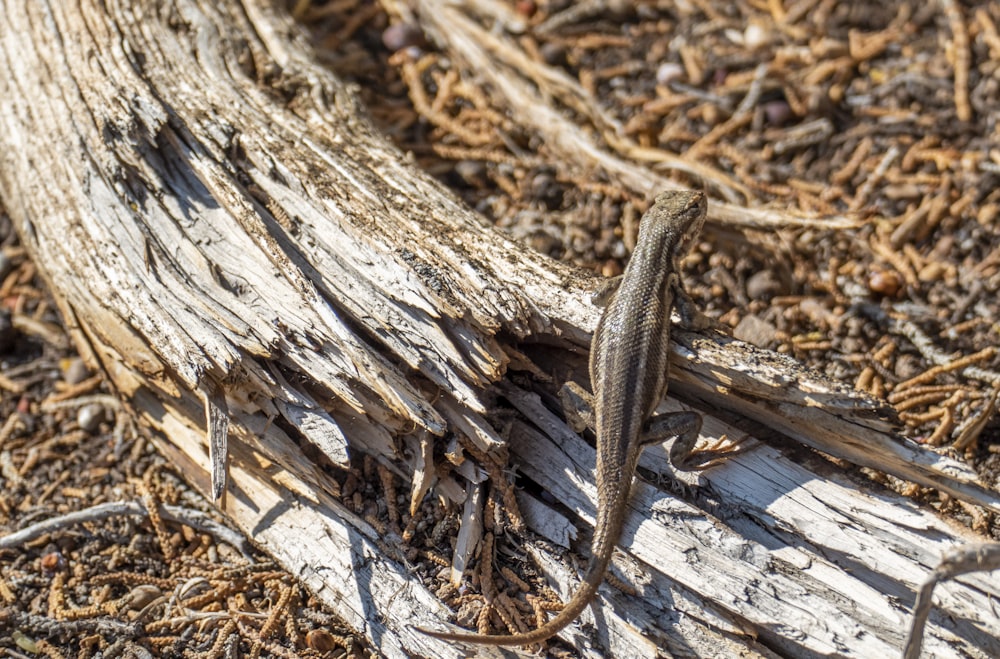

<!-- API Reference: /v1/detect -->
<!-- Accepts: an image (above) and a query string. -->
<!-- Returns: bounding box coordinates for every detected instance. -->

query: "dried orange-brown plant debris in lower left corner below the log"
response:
[0,220,371,657]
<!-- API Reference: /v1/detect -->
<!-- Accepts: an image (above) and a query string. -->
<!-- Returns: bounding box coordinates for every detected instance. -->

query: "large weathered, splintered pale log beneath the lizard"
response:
[0,0,1000,657]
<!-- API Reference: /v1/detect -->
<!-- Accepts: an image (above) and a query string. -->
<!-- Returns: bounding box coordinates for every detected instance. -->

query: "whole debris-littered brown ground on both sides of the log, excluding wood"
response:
[0,0,1000,657]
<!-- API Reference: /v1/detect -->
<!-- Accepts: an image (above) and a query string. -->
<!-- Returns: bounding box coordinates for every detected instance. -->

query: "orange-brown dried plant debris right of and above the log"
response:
[298,0,1000,508]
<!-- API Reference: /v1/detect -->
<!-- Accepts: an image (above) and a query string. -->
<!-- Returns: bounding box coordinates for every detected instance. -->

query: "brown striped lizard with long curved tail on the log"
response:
[417,190,728,646]
